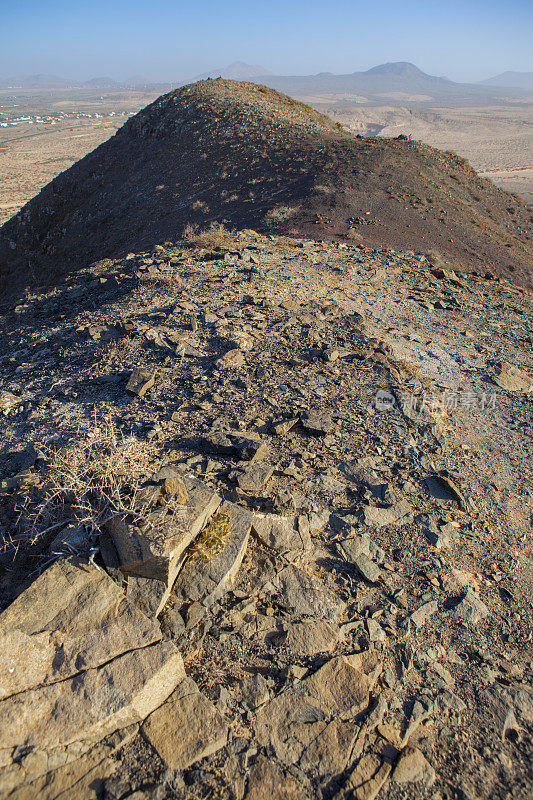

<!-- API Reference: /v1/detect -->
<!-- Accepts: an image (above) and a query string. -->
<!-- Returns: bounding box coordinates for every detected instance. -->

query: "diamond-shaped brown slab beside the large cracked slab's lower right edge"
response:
[142,678,228,770]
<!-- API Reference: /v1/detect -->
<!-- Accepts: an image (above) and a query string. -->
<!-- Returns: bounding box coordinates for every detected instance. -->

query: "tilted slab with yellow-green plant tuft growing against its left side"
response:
[173,502,252,607]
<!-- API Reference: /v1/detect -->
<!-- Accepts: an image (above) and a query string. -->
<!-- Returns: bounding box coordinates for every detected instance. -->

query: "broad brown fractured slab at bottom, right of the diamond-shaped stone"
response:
[255,657,369,771]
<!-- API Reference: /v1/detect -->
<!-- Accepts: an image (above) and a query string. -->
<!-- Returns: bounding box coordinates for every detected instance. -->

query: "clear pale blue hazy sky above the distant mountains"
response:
[0,0,533,81]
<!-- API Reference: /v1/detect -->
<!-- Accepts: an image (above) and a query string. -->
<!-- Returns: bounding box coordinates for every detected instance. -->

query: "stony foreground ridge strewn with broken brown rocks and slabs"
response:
[0,231,533,800]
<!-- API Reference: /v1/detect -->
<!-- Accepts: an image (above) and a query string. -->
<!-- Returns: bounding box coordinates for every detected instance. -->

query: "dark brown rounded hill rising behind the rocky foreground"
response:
[0,80,533,293]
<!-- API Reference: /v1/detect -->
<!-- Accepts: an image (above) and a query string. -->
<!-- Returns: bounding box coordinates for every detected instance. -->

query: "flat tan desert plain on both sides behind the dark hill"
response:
[0,86,533,224]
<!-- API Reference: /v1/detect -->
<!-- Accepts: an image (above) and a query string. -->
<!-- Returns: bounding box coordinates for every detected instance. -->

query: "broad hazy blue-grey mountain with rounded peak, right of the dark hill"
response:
[262,61,523,103]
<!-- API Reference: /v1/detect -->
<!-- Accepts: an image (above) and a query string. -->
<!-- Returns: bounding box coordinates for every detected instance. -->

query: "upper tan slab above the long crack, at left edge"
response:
[0,559,161,699]
